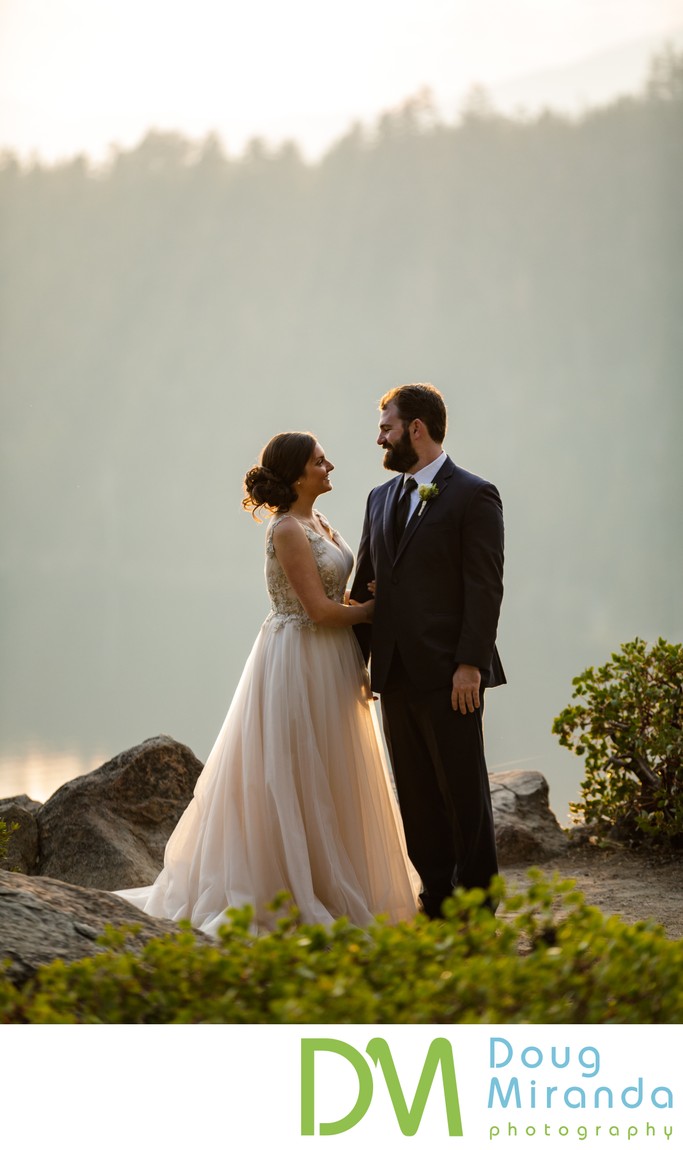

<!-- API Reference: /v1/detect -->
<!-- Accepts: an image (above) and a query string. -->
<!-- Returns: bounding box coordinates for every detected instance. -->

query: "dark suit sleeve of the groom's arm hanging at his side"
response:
[455,483,505,677]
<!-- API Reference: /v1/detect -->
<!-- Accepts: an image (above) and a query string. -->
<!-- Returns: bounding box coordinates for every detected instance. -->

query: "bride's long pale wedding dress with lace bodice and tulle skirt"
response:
[116,512,420,935]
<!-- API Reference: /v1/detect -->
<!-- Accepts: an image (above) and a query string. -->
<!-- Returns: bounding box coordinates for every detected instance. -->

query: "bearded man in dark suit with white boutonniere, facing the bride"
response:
[351,383,506,918]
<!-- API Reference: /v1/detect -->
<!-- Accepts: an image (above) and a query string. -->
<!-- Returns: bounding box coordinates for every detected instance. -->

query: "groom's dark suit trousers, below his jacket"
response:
[381,656,498,915]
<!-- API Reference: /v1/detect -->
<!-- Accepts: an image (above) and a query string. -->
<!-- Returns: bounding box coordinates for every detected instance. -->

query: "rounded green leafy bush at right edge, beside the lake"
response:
[552,638,683,848]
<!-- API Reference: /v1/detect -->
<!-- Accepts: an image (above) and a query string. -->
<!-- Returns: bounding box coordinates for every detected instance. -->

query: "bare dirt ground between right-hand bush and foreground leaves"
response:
[500,845,683,938]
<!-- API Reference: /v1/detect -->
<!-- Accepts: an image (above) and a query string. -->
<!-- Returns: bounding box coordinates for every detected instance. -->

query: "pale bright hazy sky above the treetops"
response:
[0,0,683,160]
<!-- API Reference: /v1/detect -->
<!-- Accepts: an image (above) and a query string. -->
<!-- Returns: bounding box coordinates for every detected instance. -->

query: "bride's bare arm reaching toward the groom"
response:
[273,518,375,627]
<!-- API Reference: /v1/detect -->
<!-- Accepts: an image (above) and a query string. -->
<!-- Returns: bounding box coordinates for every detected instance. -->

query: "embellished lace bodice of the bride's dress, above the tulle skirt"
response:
[266,511,353,628]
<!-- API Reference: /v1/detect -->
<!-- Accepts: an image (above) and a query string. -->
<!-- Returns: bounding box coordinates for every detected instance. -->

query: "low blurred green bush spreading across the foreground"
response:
[0,871,683,1025]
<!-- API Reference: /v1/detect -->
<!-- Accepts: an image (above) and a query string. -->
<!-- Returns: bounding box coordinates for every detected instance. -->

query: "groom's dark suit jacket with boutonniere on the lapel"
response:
[351,458,506,691]
